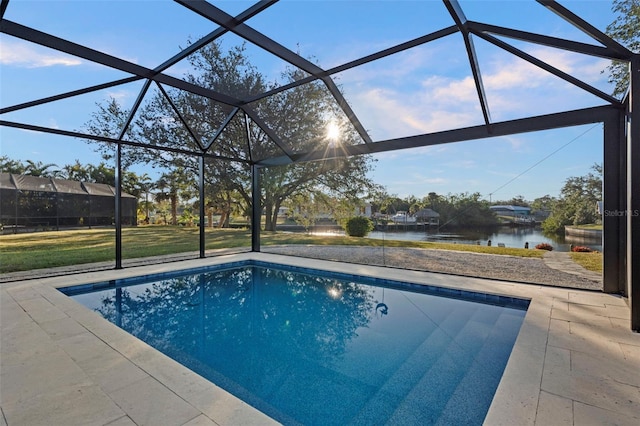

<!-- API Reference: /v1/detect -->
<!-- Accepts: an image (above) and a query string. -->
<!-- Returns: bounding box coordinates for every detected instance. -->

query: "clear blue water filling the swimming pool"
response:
[62,262,528,425]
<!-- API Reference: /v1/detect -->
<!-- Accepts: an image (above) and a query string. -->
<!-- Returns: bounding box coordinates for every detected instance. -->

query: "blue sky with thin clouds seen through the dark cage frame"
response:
[0,0,615,201]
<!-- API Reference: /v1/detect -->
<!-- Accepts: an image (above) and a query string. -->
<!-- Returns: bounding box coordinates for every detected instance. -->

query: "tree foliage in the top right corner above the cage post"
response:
[606,0,640,95]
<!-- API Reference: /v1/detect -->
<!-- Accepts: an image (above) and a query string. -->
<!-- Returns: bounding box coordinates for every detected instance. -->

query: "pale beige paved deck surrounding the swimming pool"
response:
[0,253,640,426]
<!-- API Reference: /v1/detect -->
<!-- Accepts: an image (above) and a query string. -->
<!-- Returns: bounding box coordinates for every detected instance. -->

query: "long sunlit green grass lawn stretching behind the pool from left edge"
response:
[0,225,544,273]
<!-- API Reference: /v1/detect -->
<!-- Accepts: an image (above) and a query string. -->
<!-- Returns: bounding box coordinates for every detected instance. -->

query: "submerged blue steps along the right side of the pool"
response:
[354,306,519,424]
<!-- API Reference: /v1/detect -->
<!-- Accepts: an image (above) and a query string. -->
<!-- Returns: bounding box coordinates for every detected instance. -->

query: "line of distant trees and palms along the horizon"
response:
[0,156,603,233]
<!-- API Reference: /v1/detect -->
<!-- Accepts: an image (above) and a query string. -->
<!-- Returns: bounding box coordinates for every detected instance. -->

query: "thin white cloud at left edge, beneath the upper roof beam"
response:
[0,40,82,68]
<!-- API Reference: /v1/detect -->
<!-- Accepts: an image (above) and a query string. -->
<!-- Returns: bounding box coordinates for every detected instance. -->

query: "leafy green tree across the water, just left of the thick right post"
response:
[542,164,602,234]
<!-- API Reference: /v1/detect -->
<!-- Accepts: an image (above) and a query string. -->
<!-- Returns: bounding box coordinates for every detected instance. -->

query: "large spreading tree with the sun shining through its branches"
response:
[87,42,372,230]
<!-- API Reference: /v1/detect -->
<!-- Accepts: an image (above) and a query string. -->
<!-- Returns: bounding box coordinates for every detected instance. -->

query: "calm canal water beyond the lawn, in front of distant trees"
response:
[312,226,602,251]
